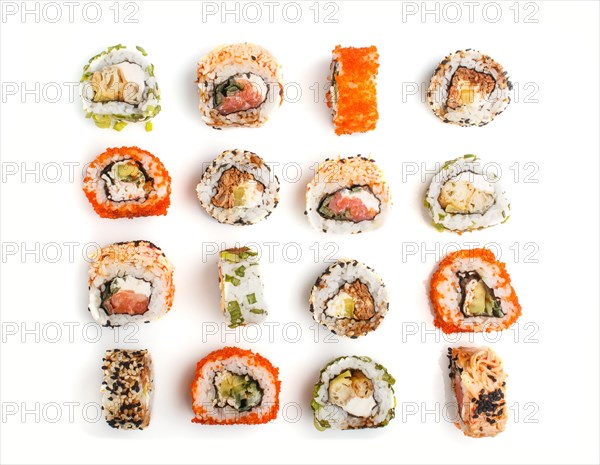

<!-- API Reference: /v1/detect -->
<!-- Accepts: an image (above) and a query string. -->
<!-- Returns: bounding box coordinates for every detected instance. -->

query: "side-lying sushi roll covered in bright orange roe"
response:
[326,45,379,136]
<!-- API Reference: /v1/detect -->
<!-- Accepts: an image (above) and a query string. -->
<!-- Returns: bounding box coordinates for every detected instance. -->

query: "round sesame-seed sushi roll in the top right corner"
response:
[427,49,512,126]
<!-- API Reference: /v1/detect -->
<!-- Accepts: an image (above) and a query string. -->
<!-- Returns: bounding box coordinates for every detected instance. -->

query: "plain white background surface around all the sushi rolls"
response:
[0,1,599,464]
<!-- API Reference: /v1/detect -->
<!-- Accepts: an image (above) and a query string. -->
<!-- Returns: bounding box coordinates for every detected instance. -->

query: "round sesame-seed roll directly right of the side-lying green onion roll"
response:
[310,259,389,338]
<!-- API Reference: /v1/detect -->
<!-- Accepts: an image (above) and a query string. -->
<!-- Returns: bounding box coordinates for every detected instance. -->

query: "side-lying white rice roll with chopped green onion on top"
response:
[219,247,267,328]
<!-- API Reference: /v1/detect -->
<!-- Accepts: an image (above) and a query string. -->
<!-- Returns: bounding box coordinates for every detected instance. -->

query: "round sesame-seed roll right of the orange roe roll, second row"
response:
[196,149,279,225]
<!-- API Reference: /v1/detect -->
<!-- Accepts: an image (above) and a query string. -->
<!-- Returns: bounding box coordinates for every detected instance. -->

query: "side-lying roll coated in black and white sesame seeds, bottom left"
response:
[100,349,153,429]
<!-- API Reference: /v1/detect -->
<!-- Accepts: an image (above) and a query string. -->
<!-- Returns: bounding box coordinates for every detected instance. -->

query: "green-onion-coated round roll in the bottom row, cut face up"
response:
[311,356,396,431]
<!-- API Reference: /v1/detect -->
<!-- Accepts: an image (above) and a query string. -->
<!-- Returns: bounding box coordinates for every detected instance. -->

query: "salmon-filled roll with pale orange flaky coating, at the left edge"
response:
[88,241,175,326]
